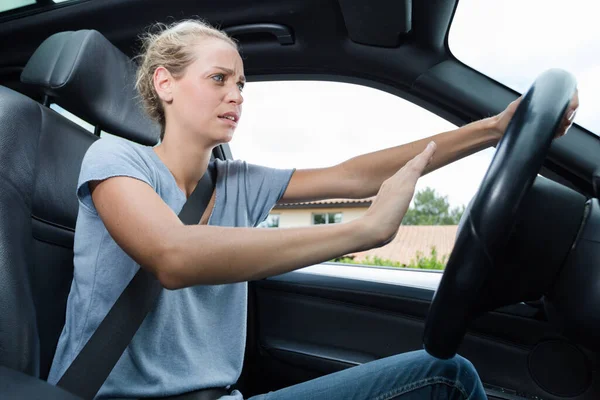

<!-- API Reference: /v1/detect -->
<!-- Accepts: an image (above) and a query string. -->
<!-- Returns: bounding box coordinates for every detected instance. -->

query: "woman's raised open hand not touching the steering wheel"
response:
[363,142,436,248]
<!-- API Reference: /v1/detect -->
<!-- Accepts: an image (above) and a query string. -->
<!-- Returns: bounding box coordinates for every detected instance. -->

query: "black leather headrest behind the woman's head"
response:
[21,30,160,145]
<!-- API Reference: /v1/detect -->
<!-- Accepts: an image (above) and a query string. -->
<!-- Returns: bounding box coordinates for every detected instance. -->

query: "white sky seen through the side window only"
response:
[230,81,494,208]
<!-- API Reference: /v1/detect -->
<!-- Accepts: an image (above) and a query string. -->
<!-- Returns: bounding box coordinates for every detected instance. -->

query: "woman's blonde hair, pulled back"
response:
[135,19,238,140]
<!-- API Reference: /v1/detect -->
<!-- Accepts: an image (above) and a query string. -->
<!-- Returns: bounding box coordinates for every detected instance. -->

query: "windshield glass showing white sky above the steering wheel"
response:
[448,0,600,135]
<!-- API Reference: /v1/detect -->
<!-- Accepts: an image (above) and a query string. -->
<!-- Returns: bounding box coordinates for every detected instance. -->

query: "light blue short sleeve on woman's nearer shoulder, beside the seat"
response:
[77,138,154,214]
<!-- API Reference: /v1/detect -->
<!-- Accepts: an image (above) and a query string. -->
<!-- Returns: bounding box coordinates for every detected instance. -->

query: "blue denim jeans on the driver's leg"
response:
[249,350,487,400]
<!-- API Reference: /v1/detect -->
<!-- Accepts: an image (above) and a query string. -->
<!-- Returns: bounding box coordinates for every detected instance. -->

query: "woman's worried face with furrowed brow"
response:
[165,38,245,145]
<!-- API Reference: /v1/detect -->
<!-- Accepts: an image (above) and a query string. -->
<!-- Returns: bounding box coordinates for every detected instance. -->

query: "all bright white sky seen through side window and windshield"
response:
[230,0,600,206]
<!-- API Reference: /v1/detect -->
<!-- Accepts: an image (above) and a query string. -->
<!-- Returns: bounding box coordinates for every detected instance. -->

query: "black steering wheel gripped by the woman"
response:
[423,69,577,359]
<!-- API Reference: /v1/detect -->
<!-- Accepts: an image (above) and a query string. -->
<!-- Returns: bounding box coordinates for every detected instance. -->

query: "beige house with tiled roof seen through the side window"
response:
[261,198,458,264]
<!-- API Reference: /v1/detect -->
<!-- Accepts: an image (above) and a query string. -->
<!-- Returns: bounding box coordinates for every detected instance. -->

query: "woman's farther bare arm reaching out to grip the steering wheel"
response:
[279,91,579,203]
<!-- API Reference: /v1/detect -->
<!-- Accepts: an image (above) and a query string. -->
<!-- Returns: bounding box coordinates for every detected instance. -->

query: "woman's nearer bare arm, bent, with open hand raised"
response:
[89,141,435,289]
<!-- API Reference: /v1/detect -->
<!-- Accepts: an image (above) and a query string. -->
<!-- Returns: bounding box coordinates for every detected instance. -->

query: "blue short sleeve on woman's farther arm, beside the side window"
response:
[243,162,295,226]
